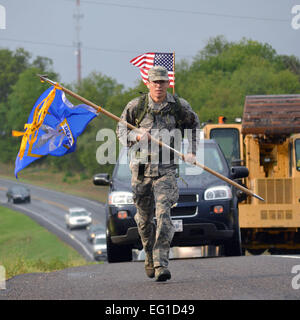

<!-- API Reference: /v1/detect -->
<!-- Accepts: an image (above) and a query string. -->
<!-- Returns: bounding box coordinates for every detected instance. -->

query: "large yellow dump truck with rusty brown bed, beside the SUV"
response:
[203,95,300,254]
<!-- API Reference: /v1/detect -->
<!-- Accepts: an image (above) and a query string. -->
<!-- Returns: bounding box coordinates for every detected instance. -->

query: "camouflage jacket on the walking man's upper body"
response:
[116,93,200,177]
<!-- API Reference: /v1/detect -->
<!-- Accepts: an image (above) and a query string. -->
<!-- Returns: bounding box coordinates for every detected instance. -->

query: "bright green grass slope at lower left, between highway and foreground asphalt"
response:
[0,206,87,279]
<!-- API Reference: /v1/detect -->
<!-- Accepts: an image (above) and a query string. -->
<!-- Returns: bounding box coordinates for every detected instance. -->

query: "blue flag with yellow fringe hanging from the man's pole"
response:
[12,86,97,178]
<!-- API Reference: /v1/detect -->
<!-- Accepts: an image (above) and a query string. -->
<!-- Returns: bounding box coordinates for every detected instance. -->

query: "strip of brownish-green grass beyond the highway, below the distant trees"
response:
[0,163,108,202]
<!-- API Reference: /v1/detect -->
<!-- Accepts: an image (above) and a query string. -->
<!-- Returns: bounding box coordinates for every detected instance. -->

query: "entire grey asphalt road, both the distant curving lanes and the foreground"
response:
[0,179,300,300]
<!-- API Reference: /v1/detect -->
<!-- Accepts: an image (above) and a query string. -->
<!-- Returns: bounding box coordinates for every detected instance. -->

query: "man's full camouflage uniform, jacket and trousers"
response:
[117,93,199,267]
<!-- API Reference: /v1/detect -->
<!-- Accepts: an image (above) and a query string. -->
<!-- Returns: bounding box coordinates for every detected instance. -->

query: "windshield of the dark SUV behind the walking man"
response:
[114,143,228,181]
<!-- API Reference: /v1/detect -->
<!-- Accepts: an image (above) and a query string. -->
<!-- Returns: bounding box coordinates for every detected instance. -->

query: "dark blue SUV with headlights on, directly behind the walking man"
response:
[94,140,248,262]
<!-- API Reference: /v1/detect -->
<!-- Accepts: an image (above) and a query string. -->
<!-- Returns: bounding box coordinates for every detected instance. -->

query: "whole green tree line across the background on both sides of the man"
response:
[0,36,300,177]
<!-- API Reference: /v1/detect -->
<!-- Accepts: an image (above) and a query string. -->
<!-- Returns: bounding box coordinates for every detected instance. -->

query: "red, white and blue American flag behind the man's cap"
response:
[130,52,175,88]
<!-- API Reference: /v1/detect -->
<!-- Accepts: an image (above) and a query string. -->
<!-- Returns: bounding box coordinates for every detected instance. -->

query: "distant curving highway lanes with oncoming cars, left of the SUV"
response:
[0,179,105,261]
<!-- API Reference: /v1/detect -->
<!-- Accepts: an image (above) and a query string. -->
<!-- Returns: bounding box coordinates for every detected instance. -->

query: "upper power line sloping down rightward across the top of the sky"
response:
[64,0,290,22]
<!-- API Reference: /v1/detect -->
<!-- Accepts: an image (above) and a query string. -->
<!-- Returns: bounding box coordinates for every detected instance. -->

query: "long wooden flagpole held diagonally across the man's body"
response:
[38,75,264,201]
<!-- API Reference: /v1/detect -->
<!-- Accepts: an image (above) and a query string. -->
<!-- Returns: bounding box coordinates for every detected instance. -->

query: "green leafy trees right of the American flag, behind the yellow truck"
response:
[176,36,300,122]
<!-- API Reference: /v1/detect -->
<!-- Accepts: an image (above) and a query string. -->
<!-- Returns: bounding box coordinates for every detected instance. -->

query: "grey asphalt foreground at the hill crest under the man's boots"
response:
[0,255,300,302]
